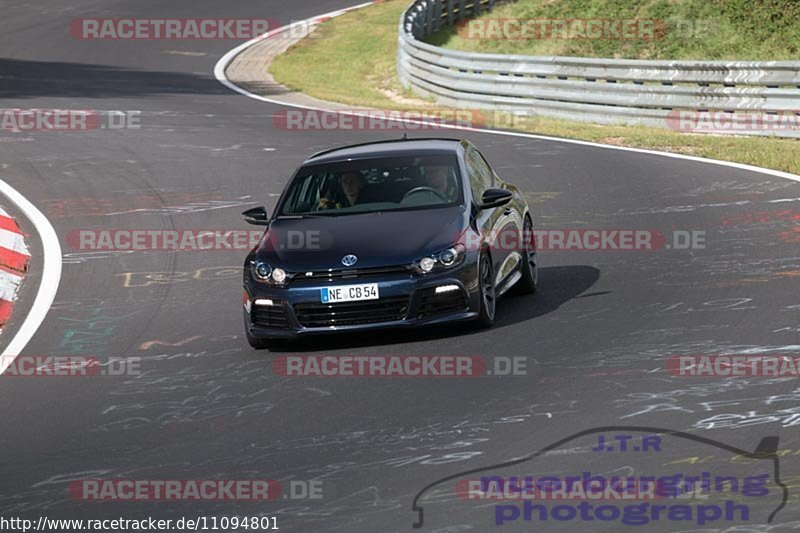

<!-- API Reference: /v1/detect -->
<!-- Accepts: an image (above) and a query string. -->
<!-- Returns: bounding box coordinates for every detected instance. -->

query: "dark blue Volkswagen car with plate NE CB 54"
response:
[243,139,537,348]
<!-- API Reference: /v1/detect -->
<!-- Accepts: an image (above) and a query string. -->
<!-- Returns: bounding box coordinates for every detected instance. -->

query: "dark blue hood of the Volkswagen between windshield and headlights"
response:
[256,206,468,272]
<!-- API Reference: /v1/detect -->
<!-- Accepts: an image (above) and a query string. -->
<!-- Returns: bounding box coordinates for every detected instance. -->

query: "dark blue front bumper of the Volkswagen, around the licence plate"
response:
[244,254,480,339]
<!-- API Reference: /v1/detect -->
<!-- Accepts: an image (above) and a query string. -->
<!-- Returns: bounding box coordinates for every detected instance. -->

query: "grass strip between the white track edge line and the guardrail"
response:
[270,0,800,174]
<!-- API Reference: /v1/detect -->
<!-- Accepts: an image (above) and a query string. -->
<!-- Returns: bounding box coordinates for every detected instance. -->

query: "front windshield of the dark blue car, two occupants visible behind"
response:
[278,155,463,217]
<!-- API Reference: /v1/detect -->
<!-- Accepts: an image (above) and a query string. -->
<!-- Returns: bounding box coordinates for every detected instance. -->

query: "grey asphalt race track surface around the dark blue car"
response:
[0,0,800,533]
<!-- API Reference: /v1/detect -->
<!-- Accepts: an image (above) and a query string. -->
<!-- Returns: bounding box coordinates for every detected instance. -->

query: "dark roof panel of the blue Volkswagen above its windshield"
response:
[303,138,462,165]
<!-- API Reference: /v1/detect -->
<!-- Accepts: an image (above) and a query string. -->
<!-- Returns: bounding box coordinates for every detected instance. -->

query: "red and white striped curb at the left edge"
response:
[0,207,31,331]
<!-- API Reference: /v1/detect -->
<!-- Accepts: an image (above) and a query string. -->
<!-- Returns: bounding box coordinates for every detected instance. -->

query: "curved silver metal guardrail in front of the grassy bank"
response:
[397,0,800,137]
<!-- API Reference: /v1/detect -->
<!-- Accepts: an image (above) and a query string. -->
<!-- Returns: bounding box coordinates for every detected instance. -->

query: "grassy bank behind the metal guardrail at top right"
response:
[429,0,800,61]
